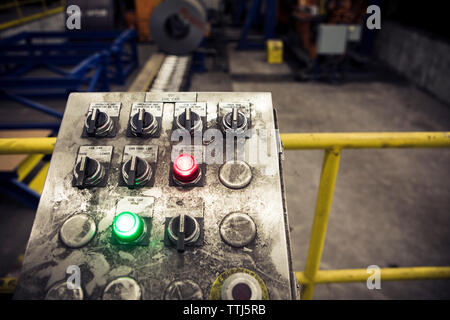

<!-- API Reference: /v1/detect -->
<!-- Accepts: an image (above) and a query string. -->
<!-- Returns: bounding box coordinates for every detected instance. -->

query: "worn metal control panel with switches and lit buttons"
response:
[14,92,298,300]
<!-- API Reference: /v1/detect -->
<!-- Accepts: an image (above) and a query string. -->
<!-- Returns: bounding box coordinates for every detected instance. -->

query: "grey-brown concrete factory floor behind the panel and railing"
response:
[0,41,450,299]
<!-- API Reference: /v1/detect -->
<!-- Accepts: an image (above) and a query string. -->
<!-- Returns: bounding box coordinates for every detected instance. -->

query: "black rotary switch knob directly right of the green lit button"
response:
[167,214,200,252]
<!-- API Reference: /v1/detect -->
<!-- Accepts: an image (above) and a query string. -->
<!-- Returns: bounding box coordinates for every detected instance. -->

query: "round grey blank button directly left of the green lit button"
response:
[59,214,97,248]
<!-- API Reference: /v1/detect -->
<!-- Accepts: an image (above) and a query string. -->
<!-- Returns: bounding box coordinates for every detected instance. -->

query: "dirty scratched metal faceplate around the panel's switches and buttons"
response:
[14,92,297,299]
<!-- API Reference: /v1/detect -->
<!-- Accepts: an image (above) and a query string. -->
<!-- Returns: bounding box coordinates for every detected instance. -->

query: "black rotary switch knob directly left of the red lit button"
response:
[122,156,152,189]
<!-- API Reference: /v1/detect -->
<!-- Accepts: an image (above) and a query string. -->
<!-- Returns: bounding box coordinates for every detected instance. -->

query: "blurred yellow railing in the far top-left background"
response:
[0,0,66,30]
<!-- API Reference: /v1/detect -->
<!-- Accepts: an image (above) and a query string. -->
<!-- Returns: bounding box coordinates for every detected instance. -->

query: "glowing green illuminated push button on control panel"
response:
[113,211,144,242]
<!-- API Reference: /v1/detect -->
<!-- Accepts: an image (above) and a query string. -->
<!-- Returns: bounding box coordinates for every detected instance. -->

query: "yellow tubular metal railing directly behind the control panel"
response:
[0,132,450,299]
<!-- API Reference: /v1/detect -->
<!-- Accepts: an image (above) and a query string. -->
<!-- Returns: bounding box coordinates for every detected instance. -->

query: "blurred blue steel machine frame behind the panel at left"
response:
[0,29,139,129]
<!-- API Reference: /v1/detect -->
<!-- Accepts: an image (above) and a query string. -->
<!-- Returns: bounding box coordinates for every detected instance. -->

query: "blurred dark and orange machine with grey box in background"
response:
[279,0,371,80]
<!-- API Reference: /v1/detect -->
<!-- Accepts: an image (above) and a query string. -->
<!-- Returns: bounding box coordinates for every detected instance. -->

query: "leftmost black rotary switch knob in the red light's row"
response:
[74,156,105,188]
